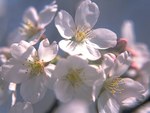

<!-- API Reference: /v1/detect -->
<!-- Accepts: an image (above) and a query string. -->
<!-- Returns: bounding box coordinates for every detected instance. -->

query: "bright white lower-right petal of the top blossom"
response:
[80,44,101,60]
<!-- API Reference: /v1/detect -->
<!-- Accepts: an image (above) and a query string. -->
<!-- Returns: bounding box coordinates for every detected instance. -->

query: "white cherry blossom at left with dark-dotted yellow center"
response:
[2,39,58,103]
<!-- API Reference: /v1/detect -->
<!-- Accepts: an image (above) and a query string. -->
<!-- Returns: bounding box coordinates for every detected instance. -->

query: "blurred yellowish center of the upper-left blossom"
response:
[20,19,39,38]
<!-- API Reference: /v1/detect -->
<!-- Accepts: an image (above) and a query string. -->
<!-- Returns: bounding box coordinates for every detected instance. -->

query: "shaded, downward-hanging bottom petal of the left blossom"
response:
[20,75,47,104]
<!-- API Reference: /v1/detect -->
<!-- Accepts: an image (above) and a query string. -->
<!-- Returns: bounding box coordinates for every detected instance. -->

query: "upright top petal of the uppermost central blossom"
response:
[75,0,99,29]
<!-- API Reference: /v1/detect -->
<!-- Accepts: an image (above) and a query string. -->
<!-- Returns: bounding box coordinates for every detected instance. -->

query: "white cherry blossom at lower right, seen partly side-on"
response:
[94,51,144,113]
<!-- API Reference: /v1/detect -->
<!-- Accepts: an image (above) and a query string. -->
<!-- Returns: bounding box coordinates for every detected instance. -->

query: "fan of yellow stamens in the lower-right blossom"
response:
[104,77,124,95]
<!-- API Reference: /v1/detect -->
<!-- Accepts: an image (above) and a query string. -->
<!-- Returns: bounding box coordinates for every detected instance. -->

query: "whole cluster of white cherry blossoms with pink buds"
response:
[0,0,150,113]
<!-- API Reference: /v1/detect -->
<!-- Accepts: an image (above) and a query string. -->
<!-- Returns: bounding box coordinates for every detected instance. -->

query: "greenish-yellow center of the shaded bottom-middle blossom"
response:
[66,69,82,86]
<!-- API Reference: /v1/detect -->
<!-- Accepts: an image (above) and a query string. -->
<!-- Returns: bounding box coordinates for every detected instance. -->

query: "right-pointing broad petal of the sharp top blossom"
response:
[90,28,117,49]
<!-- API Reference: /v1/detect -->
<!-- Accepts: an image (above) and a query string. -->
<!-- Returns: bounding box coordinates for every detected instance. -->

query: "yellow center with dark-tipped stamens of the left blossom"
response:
[28,60,44,76]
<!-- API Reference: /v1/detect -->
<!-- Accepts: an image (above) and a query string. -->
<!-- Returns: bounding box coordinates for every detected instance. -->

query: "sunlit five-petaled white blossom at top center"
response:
[55,0,117,60]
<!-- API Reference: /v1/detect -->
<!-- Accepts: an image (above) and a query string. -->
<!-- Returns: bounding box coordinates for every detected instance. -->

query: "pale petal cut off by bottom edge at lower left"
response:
[9,102,33,113]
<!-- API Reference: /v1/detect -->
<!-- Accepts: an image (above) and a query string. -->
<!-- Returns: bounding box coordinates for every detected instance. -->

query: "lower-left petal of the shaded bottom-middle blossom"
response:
[54,80,74,102]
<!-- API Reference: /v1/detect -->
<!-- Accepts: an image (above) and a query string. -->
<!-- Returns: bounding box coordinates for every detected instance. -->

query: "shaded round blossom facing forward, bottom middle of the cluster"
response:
[53,56,99,102]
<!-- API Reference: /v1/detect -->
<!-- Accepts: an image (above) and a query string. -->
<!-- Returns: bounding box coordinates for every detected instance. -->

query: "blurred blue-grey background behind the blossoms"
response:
[0,0,150,113]
